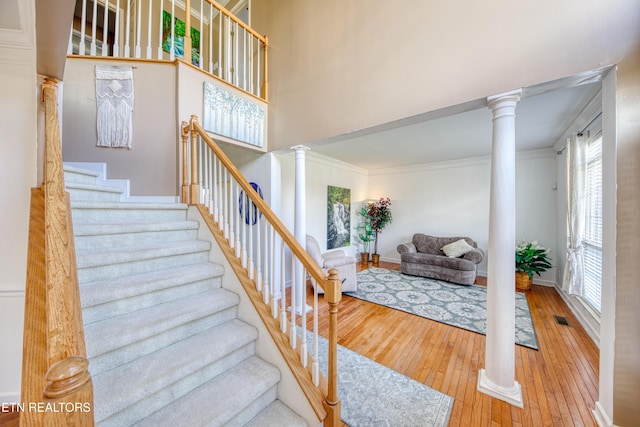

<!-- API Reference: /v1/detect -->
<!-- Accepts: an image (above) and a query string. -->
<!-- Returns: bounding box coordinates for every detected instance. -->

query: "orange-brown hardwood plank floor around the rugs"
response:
[308,262,599,427]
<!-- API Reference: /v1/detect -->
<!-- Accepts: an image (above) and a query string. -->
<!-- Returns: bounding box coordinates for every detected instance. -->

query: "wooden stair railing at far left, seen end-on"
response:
[18,79,94,427]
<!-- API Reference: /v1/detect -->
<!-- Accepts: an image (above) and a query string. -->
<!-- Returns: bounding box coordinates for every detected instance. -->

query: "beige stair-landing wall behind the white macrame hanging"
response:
[62,59,178,196]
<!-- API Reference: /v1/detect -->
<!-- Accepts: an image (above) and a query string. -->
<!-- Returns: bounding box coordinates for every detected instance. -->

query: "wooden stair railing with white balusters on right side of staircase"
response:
[182,116,342,426]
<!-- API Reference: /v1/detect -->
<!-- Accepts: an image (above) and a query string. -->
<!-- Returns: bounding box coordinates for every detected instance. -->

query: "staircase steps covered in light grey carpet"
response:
[64,165,307,427]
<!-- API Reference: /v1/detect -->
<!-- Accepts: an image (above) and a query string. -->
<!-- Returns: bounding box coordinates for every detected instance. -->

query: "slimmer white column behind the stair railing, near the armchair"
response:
[291,145,311,314]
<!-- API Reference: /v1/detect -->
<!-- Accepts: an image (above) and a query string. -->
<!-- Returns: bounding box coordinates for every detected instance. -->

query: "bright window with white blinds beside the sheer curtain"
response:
[583,132,602,313]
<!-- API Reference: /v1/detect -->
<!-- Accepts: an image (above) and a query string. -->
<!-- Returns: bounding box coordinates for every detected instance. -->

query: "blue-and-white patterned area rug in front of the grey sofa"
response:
[345,267,538,350]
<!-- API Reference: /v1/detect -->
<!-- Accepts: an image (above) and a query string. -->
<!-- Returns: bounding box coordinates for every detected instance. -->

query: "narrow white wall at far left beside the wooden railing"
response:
[0,1,39,402]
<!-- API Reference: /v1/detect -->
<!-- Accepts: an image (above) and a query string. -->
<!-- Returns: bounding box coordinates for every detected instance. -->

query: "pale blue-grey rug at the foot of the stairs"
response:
[307,333,453,427]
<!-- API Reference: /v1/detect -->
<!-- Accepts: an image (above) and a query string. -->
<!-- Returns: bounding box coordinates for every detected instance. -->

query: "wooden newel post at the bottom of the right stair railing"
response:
[324,268,342,426]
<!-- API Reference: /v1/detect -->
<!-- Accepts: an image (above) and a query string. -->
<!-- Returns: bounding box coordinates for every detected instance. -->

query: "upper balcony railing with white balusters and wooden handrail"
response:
[67,0,268,101]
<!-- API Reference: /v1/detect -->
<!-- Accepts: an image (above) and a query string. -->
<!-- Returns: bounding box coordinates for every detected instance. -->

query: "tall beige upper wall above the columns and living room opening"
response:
[251,0,640,152]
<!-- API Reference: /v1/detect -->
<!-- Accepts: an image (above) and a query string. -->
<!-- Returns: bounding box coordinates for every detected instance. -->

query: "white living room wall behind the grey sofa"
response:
[369,150,556,284]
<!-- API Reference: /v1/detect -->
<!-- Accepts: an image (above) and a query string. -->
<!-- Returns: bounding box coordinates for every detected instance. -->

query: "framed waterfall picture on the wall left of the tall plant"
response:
[327,185,351,249]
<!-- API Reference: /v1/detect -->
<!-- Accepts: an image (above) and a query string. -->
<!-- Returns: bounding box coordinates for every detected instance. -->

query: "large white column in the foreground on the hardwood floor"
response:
[478,90,523,408]
